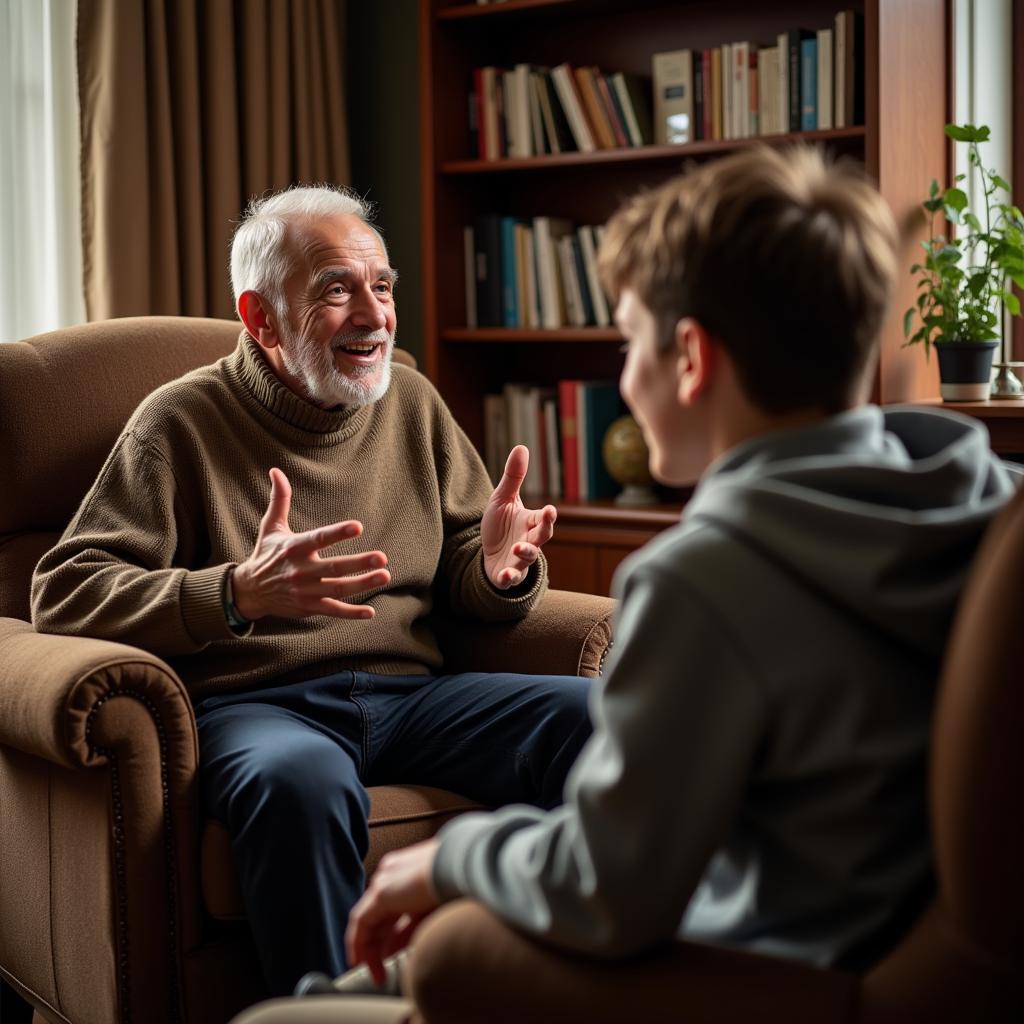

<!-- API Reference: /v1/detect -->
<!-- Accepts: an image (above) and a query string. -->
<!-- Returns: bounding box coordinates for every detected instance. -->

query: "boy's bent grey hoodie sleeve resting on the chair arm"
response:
[433,565,765,955]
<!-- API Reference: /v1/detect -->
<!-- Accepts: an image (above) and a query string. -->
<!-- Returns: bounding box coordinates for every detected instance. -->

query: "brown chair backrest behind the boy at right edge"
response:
[931,493,1024,950]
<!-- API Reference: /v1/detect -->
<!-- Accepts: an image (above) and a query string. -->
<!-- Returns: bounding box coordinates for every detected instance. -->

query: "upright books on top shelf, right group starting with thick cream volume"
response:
[651,10,863,142]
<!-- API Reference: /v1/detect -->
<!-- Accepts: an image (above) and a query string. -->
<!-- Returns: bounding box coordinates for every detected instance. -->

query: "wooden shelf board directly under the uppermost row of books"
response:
[438,125,865,174]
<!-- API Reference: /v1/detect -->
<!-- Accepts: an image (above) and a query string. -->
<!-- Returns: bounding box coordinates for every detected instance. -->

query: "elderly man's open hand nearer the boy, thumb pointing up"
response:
[480,444,558,590]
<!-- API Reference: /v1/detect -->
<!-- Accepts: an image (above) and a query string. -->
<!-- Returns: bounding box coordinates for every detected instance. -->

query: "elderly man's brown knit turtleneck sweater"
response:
[32,333,547,700]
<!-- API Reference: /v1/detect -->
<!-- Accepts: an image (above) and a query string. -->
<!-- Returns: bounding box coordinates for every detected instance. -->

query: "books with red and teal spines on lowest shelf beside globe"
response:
[483,380,624,502]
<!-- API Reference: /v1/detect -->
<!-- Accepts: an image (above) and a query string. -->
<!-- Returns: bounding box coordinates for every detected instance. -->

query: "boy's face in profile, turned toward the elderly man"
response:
[615,288,693,485]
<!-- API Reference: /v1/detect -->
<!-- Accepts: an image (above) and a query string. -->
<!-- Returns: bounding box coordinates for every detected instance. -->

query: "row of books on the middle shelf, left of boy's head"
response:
[463,214,611,329]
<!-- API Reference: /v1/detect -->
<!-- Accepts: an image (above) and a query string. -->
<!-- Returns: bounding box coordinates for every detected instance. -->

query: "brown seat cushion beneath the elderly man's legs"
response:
[200,785,480,921]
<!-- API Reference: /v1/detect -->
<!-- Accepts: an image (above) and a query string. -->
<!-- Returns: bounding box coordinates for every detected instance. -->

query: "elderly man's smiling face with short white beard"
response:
[281,215,396,409]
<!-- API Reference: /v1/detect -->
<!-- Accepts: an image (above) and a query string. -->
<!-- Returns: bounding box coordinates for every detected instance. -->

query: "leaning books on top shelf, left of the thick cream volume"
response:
[469,63,652,160]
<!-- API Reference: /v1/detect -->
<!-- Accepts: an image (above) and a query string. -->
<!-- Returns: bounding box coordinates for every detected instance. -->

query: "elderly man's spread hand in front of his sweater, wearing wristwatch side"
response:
[231,469,391,620]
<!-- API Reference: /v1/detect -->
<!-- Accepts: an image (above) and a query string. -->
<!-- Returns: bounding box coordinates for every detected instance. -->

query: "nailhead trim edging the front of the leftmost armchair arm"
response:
[85,690,181,1024]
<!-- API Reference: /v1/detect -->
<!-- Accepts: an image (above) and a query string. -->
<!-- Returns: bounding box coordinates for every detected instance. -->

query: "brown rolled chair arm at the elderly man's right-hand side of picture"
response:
[436,590,615,677]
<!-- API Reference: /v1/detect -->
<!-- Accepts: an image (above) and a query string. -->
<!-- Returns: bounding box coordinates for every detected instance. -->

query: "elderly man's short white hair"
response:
[231,184,387,316]
